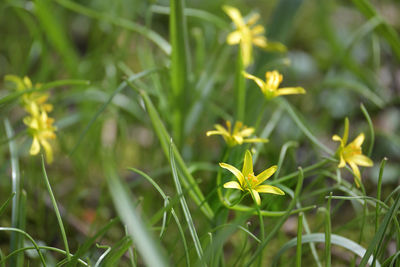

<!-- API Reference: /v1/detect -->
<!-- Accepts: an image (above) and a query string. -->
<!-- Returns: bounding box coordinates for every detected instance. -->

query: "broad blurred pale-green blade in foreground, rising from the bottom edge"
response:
[104,160,168,267]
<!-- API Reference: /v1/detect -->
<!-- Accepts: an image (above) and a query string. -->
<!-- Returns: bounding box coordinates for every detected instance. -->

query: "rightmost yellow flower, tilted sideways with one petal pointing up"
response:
[332,118,374,187]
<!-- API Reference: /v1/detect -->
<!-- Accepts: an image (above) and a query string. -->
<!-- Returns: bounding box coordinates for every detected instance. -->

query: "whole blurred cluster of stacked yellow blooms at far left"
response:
[5,75,56,163]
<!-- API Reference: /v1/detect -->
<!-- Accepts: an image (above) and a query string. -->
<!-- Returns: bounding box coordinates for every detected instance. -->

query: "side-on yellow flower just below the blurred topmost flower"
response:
[243,70,306,99]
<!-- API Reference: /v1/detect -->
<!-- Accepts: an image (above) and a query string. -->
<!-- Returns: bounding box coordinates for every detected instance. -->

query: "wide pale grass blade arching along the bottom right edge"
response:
[271,233,381,267]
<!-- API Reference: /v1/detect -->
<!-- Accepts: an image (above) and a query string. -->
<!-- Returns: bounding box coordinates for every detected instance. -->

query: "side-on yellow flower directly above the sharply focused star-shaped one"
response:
[206,121,268,146]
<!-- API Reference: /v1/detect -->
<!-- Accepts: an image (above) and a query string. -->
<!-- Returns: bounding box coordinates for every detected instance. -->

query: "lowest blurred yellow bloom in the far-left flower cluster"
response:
[24,111,56,163]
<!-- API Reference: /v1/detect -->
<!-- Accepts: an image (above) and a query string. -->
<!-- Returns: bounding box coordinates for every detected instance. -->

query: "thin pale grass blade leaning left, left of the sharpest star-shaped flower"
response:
[169,140,203,260]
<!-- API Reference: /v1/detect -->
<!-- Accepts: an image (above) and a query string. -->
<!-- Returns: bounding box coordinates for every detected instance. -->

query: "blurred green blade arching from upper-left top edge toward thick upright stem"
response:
[55,0,171,55]
